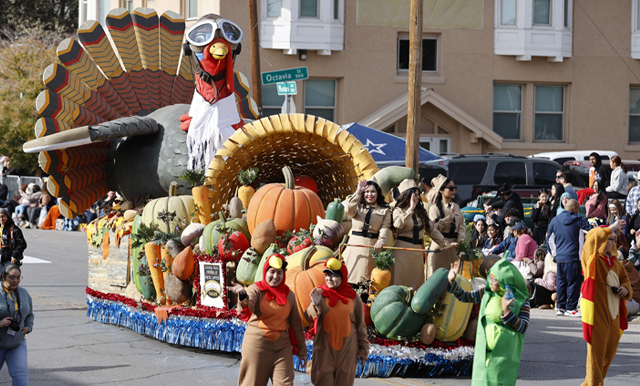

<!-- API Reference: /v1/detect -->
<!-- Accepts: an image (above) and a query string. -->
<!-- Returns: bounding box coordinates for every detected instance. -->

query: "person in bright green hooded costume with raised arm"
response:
[447,255,530,386]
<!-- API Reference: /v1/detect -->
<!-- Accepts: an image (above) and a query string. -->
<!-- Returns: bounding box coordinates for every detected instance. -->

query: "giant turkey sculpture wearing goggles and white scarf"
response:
[24,8,257,218]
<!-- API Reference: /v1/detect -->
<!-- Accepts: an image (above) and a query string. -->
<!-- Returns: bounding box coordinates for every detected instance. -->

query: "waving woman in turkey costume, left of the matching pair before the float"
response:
[231,253,307,386]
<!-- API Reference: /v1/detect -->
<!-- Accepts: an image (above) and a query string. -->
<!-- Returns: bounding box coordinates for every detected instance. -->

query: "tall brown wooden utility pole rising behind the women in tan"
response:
[406,0,423,173]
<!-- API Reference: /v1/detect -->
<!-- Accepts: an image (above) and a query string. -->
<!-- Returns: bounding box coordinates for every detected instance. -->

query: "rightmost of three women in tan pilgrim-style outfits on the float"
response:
[426,174,465,279]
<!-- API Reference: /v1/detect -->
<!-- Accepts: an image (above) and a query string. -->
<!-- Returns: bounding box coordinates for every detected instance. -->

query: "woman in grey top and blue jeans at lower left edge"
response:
[0,264,33,386]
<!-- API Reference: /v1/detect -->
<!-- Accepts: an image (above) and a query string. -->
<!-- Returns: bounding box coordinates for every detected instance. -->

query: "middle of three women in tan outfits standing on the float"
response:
[391,179,449,290]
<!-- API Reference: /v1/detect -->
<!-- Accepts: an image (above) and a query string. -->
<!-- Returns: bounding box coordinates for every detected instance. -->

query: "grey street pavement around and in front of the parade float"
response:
[0,230,640,386]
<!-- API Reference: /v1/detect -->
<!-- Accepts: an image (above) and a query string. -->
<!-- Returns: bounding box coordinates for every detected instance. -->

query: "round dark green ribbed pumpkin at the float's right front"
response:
[371,285,427,340]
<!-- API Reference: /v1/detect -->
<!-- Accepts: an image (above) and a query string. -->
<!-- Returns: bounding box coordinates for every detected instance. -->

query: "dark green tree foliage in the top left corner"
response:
[0,0,80,38]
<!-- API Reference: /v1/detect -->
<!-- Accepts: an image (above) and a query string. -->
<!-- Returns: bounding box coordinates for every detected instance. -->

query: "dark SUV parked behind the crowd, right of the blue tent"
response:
[378,153,561,207]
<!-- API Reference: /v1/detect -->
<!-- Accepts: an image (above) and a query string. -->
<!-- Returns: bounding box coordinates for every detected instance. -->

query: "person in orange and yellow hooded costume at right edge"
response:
[580,221,632,386]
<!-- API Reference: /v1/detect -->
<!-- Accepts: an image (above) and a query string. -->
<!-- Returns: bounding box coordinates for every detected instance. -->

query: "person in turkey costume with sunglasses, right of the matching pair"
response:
[304,258,369,386]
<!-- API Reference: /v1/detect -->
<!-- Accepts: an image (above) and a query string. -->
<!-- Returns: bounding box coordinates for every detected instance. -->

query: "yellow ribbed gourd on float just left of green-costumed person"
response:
[429,275,473,342]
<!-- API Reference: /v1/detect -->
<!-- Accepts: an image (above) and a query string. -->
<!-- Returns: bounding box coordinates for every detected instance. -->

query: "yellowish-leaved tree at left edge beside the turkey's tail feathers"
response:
[0,29,65,171]
